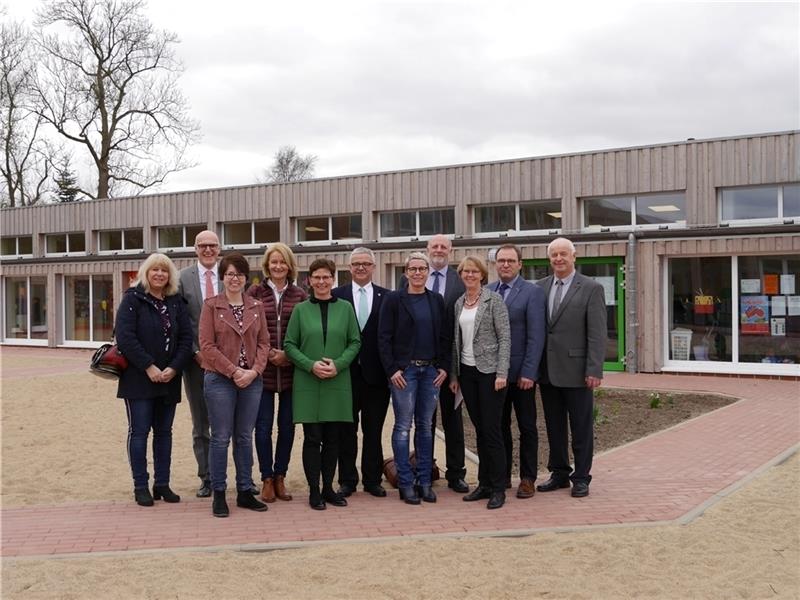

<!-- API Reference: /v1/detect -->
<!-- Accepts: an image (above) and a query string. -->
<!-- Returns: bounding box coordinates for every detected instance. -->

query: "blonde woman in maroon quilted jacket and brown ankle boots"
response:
[247,242,308,502]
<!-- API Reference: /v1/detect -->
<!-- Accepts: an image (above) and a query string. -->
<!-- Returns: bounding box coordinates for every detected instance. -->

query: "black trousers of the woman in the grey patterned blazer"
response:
[458,364,506,492]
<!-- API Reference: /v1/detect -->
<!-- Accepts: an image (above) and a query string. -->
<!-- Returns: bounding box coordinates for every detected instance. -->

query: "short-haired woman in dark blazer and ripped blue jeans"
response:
[378,252,452,504]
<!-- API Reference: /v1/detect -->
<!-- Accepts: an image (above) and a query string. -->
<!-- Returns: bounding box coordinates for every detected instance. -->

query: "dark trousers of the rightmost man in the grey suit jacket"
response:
[539,383,594,483]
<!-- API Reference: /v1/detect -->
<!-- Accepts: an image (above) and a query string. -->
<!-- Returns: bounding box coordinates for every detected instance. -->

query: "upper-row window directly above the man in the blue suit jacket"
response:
[474,200,561,233]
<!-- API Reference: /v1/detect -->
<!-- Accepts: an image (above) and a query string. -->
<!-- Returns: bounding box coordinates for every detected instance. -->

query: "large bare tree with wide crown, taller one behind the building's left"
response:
[36,0,199,198]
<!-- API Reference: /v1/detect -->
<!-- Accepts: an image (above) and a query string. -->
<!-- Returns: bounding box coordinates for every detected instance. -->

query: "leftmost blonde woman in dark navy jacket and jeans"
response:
[115,254,192,506]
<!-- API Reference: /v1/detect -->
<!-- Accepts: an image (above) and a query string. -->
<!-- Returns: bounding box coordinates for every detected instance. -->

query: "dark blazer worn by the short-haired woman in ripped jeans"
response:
[378,289,453,377]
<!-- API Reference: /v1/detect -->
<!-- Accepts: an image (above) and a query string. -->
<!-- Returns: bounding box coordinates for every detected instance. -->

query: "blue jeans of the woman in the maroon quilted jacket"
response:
[256,389,294,481]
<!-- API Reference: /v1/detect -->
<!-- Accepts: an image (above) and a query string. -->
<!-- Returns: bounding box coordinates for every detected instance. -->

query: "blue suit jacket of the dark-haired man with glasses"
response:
[489,277,547,383]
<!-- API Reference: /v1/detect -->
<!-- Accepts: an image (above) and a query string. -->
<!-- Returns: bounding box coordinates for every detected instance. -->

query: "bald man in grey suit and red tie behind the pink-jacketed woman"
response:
[179,231,219,498]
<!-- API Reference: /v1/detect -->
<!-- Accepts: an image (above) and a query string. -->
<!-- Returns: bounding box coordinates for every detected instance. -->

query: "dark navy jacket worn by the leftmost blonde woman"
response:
[114,286,192,402]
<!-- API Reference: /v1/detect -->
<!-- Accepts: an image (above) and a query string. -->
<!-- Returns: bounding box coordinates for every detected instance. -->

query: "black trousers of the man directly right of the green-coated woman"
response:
[339,377,389,489]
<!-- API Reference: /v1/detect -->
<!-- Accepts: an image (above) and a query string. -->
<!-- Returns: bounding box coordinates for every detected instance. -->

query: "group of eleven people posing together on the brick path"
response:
[116,231,606,517]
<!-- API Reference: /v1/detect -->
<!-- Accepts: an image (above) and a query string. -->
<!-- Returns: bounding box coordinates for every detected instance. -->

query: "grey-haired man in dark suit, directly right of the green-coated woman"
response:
[333,248,389,498]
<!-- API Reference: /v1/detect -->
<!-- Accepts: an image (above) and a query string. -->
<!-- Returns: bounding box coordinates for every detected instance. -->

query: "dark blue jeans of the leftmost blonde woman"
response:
[125,398,175,489]
